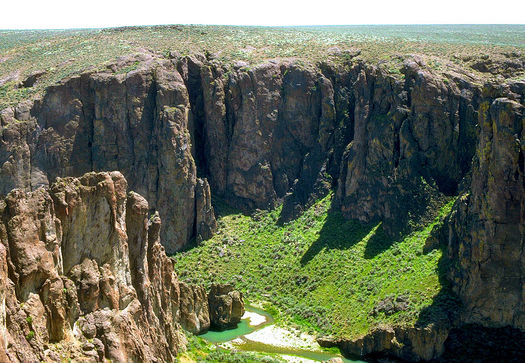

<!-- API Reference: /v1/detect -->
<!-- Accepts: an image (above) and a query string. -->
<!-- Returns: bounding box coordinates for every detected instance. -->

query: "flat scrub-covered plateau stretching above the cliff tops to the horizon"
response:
[0,25,525,109]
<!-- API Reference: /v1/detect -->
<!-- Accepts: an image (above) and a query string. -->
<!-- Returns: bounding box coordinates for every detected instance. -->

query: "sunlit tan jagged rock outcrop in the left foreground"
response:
[0,172,202,362]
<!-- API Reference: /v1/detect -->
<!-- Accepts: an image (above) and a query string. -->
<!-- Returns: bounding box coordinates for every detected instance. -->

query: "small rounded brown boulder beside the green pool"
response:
[208,284,245,330]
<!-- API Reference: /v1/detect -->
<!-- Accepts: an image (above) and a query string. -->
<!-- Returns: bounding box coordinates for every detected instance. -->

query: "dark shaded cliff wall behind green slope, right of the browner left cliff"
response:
[179,58,480,230]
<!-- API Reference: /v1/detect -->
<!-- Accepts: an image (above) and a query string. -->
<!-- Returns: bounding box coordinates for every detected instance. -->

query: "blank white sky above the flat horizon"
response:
[0,0,525,29]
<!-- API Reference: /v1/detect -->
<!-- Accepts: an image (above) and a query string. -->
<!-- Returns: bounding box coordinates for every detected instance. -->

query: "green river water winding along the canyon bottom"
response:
[201,306,364,363]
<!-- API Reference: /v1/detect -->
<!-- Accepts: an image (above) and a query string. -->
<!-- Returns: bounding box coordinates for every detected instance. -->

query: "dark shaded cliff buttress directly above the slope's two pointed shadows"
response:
[337,59,480,233]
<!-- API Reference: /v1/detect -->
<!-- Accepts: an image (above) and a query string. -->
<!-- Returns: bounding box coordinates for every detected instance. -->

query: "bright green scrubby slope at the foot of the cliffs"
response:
[173,196,454,338]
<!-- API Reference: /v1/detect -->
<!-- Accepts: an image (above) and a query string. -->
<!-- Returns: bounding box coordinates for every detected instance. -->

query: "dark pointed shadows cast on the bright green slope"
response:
[301,209,394,266]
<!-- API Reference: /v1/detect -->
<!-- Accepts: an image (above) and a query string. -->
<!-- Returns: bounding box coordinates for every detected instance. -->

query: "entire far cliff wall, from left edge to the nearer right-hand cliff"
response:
[0,54,480,253]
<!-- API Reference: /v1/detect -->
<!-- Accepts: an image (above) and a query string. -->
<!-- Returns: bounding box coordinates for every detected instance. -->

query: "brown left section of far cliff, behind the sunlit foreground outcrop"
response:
[0,54,214,253]
